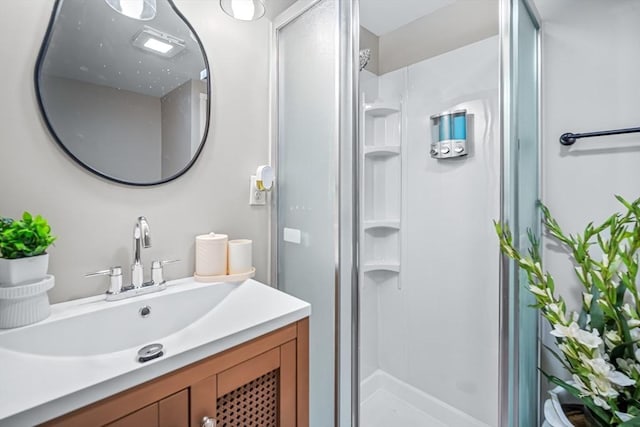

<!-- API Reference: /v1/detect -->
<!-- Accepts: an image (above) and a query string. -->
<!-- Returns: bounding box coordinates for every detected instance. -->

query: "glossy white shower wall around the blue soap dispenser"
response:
[360,37,500,426]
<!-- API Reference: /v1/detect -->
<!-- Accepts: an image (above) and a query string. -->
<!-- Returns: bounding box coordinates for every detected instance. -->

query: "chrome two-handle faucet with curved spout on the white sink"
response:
[85,216,178,301]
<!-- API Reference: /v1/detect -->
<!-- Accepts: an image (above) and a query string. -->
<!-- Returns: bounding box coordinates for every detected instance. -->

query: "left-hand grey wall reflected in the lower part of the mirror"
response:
[41,76,162,182]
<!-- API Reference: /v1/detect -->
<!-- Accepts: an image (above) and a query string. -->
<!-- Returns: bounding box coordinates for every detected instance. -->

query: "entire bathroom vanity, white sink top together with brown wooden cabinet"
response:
[0,278,310,427]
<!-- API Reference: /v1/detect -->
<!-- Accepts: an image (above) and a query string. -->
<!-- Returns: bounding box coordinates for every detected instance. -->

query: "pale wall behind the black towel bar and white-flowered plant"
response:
[536,0,640,384]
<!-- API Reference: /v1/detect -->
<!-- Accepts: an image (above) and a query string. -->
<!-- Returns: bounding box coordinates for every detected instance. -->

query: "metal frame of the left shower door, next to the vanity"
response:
[268,0,360,427]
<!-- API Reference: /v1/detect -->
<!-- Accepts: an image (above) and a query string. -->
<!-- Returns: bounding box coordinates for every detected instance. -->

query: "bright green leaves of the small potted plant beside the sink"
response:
[0,212,56,259]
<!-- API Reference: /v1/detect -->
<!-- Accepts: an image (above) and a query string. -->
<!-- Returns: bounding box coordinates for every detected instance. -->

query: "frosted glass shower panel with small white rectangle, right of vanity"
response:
[274,0,339,427]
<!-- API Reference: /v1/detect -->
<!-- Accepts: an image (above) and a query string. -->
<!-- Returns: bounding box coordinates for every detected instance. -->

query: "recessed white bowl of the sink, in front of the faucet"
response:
[0,283,238,356]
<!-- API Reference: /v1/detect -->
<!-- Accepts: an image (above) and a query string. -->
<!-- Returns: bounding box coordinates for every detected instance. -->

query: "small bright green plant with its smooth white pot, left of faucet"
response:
[0,212,56,286]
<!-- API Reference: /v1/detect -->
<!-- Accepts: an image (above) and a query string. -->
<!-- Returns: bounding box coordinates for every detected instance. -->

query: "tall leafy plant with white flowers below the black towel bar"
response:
[495,196,640,427]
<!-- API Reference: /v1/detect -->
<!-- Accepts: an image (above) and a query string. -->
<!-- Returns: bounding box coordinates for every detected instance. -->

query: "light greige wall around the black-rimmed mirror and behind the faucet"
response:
[0,0,269,301]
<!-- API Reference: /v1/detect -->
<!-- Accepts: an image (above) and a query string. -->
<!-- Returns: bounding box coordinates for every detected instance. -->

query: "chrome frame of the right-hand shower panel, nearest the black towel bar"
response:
[498,0,543,427]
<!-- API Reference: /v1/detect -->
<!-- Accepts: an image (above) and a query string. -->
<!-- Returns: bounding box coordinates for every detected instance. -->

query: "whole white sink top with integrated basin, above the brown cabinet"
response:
[0,278,311,427]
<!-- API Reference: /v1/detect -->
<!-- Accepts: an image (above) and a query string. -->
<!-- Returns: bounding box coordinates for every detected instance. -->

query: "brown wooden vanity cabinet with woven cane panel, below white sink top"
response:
[43,319,309,427]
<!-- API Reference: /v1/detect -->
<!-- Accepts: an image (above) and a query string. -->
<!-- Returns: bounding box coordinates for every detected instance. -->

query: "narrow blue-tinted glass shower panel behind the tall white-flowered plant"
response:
[505,0,540,427]
